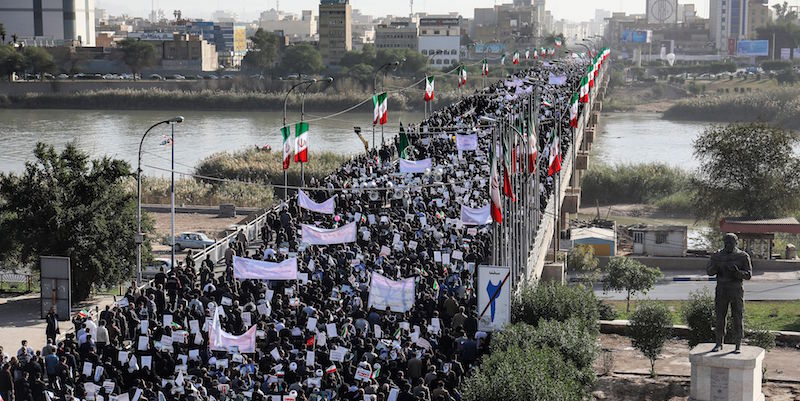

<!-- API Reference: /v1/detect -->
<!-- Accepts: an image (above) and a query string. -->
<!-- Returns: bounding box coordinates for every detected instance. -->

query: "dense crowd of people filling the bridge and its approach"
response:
[0,55,586,401]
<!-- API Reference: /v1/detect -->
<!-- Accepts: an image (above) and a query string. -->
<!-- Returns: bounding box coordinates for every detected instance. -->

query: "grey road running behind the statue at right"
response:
[594,280,800,301]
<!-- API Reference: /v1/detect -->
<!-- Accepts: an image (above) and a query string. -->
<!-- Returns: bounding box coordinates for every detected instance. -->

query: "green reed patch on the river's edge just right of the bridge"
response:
[581,163,691,205]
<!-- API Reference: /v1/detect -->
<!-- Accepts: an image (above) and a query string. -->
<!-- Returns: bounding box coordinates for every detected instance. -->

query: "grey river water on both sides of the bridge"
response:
[0,110,706,175]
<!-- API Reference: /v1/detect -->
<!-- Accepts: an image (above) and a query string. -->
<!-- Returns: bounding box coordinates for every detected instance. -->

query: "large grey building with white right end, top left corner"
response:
[0,0,95,46]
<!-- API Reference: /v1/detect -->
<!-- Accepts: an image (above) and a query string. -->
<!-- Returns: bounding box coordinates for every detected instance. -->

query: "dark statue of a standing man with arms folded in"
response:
[706,233,753,354]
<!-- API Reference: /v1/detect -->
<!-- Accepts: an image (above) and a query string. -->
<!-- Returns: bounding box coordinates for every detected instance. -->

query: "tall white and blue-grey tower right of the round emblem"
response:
[709,0,750,55]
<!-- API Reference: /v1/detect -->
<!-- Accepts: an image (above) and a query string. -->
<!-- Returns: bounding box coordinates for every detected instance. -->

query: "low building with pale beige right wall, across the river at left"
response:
[161,33,219,72]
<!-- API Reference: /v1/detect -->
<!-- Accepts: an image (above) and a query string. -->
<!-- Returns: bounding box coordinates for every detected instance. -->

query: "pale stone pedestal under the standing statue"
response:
[689,343,765,401]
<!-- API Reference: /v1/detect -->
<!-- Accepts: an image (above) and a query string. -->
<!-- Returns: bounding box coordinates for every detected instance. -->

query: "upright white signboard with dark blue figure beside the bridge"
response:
[478,266,511,331]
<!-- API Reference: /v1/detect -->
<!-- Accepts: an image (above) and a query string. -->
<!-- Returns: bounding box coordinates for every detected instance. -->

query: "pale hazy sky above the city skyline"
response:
[95,0,798,22]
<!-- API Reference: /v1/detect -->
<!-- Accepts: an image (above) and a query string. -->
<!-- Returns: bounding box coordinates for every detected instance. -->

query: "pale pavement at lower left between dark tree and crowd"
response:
[0,293,114,355]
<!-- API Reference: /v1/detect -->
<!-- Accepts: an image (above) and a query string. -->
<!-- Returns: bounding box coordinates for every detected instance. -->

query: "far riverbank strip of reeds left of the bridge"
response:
[0,89,458,112]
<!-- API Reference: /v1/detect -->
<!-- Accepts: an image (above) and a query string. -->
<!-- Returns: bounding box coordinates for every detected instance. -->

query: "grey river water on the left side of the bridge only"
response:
[0,110,423,176]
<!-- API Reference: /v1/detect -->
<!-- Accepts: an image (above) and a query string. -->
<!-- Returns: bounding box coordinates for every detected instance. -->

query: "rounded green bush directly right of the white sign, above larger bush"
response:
[511,283,598,333]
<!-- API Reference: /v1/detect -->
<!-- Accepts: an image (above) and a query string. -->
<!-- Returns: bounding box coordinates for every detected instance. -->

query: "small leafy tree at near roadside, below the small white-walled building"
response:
[603,256,664,312]
